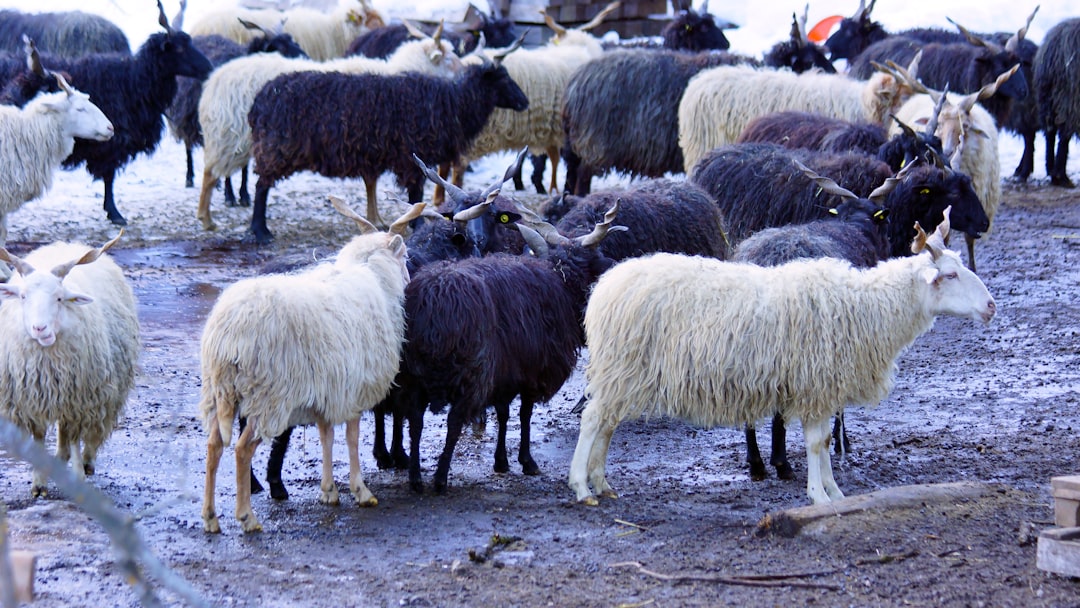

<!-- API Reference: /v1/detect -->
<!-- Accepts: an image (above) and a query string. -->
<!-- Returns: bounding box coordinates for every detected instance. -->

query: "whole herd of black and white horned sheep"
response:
[0,0,1080,532]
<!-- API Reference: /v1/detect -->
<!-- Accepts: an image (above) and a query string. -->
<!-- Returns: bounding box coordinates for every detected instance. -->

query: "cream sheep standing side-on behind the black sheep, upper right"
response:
[678,66,910,173]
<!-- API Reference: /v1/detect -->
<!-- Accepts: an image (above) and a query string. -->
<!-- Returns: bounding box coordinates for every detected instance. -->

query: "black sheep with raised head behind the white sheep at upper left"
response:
[42,1,213,226]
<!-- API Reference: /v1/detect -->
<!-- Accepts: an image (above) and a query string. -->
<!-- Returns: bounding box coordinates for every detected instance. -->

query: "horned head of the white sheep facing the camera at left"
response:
[0,230,123,347]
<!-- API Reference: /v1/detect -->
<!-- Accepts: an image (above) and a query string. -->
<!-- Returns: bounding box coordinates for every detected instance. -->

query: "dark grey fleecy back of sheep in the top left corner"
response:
[0,10,132,57]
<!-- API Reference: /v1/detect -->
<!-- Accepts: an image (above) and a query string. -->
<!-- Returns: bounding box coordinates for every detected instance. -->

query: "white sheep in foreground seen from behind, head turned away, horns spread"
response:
[199,198,424,532]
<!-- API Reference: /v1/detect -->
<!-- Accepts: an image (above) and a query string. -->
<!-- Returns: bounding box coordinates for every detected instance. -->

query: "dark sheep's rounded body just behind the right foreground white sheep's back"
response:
[544,179,730,261]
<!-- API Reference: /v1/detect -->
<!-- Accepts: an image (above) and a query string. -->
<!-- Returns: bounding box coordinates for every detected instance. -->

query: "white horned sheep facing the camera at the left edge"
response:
[0,235,139,497]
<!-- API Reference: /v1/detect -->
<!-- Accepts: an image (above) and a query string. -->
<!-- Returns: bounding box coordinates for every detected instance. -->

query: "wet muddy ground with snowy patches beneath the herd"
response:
[0,141,1080,607]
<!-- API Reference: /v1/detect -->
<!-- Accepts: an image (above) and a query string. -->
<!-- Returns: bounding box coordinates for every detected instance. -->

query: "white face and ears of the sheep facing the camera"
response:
[0,271,94,347]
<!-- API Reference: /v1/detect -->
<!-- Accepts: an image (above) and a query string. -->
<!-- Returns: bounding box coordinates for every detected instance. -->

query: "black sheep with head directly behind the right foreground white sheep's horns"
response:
[690,144,989,256]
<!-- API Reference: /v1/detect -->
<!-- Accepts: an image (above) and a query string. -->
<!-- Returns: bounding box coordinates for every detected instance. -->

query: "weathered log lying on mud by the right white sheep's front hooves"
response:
[756,482,998,538]
